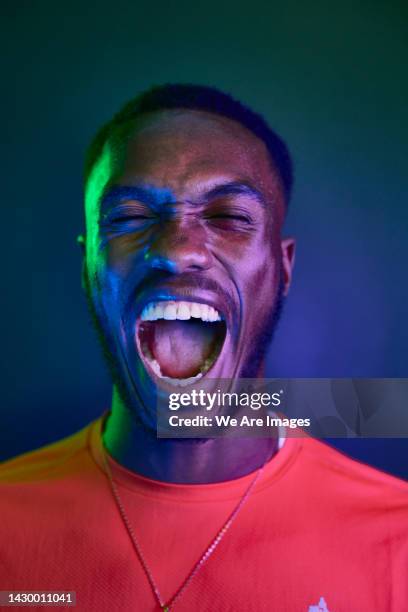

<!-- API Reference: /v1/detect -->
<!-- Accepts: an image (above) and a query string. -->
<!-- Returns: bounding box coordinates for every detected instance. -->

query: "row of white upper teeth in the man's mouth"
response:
[140,301,221,322]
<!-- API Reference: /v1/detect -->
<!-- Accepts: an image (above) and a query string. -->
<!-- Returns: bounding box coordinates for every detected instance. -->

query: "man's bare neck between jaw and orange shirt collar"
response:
[103,389,278,484]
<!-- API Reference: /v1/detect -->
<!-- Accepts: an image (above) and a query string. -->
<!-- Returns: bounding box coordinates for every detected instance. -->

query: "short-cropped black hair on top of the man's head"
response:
[84,84,293,204]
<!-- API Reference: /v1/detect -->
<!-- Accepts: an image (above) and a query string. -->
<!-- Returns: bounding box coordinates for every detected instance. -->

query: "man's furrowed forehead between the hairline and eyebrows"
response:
[109,110,280,199]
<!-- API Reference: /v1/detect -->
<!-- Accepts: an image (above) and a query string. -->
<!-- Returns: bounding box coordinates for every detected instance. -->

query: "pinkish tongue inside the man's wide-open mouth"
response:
[150,320,216,378]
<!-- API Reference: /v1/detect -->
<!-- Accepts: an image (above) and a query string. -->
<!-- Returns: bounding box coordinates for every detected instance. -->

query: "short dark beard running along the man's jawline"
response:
[84,267,285,428]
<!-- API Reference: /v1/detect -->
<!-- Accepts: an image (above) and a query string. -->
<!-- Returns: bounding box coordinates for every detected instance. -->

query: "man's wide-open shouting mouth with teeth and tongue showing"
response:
[137,301,227,385]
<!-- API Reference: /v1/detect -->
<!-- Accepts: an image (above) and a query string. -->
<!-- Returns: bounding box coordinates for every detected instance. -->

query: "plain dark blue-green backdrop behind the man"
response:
[0,0,408,476]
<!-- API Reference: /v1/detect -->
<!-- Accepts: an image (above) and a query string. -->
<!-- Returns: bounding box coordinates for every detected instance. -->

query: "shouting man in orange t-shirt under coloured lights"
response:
[0,85,408,612]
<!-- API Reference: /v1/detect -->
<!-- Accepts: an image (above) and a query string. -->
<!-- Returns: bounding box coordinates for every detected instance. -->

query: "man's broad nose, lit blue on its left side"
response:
[145,221,212,274]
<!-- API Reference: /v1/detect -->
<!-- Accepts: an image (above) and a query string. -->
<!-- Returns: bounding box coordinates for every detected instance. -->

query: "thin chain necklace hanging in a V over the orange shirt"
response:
[102,445,275,612]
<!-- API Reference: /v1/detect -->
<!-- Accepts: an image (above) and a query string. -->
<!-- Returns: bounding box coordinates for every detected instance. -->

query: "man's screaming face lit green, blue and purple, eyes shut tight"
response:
[85,110,294,428]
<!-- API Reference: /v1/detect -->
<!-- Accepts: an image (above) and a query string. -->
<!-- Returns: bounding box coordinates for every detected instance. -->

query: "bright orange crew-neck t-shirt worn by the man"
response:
[0,419,408,612]
